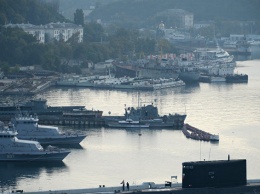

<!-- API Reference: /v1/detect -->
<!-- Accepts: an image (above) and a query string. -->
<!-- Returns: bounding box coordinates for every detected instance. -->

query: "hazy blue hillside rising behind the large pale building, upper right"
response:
[91,0,260,27]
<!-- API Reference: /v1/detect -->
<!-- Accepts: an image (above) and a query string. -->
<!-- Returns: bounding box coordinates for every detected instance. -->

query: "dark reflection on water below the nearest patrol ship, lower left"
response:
[0,162,67,191]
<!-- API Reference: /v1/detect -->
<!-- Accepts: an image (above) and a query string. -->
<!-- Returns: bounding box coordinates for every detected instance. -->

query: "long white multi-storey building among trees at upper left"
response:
[5,22,83,43]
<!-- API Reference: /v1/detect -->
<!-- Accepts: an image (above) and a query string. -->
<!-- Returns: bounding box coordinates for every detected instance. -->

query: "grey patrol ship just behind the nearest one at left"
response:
[11,114,86,145]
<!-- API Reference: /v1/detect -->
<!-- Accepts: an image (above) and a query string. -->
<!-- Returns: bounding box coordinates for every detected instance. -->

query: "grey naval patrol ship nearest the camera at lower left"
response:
[0,122,70,162]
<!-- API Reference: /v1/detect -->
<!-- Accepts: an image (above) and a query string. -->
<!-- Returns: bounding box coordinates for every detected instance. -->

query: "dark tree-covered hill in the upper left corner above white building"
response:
[0,0,68,25]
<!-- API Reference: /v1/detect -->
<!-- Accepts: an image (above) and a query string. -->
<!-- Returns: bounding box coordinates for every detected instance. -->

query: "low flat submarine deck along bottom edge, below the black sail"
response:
[19,179,260,194]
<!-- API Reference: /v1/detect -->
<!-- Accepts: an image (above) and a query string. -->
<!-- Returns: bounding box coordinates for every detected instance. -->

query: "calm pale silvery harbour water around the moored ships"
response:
[0,53,260,192]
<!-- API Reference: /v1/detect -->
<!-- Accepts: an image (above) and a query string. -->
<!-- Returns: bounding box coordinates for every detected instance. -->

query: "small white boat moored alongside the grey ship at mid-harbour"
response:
[108,119,149,128]
